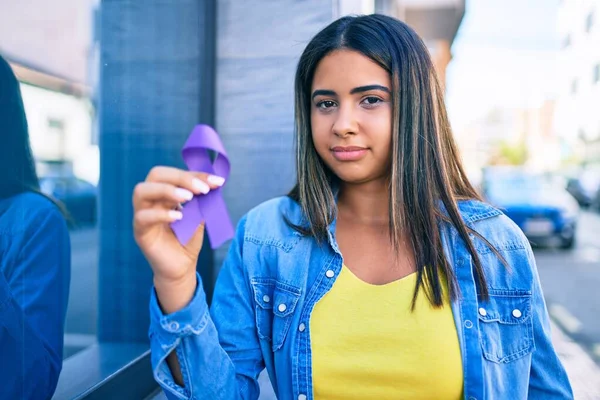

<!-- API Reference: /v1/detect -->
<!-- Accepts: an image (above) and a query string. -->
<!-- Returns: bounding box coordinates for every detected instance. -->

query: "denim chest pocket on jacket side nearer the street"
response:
[478,289,535,363]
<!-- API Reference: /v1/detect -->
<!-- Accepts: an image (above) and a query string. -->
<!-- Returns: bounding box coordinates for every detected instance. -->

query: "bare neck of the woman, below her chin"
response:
[337,179,389,225]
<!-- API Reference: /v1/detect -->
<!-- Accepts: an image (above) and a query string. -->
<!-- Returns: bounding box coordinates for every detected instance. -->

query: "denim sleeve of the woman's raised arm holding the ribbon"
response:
[149,217,264,400]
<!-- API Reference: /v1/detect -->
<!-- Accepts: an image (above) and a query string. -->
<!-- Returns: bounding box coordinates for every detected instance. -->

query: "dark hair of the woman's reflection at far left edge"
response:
[0,56,40,199]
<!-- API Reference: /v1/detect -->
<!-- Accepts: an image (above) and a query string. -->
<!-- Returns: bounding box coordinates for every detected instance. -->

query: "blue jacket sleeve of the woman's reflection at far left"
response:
[0,206,71,399]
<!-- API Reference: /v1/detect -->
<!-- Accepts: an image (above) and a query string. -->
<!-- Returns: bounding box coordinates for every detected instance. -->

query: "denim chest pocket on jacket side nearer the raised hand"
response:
[252,278,301,351]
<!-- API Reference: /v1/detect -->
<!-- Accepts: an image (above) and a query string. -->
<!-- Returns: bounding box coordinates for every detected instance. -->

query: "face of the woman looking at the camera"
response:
[311,50,392,183]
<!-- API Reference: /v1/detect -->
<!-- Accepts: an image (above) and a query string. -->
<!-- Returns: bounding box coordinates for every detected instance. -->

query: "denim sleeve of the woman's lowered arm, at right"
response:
[528,245,573,400]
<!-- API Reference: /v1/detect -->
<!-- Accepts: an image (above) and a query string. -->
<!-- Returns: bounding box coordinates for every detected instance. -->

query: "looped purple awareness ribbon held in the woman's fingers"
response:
[171,125,234,249]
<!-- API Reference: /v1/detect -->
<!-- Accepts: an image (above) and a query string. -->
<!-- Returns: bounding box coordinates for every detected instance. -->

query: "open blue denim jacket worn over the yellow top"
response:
[149,197,573,400]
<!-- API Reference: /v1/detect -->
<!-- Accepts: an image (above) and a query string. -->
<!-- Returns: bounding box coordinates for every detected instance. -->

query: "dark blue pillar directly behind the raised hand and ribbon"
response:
[98,0,216,341]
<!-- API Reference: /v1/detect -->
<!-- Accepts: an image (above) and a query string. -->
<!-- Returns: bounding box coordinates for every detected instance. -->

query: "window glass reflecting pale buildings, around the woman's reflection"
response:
[0,0,99,359]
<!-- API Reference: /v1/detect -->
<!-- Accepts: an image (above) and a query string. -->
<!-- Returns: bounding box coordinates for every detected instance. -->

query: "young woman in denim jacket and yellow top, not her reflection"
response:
[133,15,573,400]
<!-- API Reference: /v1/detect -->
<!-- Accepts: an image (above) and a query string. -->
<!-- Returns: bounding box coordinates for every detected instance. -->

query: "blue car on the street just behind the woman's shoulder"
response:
[482,169,579,249]
